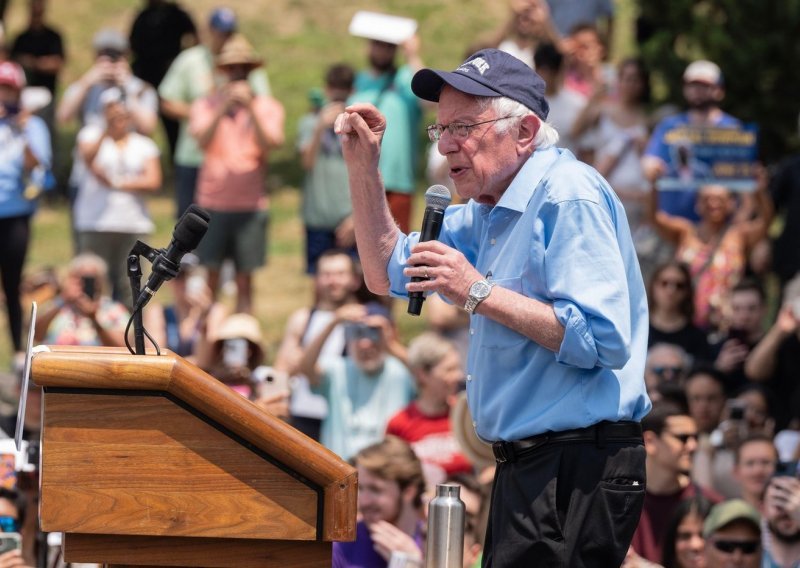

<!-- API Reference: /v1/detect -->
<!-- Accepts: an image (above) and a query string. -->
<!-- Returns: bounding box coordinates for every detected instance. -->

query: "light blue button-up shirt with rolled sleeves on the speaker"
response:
[387,144,651,441]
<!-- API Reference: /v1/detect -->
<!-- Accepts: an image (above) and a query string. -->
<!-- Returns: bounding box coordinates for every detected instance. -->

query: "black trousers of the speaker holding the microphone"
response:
[483,439,645,568]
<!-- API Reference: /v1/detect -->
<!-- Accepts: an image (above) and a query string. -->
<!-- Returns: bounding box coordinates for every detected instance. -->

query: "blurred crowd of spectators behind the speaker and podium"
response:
[0,0,800,568]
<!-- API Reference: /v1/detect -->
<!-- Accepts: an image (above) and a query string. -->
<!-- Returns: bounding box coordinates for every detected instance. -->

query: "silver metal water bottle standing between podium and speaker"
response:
[425,483,465,568]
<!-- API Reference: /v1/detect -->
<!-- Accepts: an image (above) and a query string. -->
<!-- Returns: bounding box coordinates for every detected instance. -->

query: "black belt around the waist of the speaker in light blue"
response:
[492,422,642,463]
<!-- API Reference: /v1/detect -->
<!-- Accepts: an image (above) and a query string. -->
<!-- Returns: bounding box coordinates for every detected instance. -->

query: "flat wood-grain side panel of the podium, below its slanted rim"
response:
[41,393,317,540]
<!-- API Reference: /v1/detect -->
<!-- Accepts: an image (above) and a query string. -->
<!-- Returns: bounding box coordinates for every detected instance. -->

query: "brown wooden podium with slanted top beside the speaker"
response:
[31,347,357,568]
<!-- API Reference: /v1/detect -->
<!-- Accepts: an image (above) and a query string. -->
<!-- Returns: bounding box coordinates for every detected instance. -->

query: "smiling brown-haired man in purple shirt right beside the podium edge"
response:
[333,436,425,568]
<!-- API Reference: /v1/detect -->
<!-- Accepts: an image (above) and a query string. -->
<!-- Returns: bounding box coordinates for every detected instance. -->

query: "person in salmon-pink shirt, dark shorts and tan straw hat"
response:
[189,35,284,313]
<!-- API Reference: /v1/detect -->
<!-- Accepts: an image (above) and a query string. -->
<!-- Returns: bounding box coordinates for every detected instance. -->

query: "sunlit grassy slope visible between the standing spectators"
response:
[0,0,633,369]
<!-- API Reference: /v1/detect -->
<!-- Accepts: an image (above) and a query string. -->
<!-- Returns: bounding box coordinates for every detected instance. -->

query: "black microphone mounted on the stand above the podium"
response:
[133,205,211,312]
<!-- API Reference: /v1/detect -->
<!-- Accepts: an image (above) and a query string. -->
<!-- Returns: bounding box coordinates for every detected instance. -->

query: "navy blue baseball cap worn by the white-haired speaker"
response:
[411,49,550,120]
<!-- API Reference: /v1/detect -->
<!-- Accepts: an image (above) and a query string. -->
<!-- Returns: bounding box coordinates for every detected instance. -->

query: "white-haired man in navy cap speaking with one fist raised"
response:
[335,49,650,568]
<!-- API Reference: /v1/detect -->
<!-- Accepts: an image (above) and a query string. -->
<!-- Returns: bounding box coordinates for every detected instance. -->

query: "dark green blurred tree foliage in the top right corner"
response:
[637,0,800,164]
